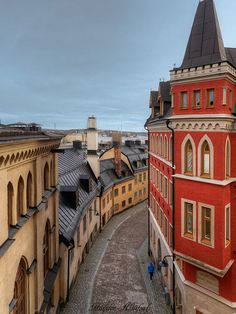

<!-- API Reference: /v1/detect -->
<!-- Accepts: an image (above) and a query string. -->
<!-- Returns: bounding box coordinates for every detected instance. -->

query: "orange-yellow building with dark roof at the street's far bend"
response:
[100,141,148,228]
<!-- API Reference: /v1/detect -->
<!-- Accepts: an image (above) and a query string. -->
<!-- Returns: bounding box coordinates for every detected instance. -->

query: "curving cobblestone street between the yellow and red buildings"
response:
[61,203,171,314]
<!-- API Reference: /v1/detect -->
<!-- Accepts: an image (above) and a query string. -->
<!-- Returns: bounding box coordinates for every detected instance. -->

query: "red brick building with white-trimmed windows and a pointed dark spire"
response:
[146,0,236,314]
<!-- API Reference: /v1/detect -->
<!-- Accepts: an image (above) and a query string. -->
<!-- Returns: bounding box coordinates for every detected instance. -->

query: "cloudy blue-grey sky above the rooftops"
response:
[0,0,236,131]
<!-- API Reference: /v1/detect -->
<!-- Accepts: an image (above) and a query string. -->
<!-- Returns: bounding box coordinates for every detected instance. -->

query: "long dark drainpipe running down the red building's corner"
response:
[166,120,175,314]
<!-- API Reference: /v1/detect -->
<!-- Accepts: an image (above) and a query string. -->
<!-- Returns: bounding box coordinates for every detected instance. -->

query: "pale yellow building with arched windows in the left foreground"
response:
[0,134,60,314]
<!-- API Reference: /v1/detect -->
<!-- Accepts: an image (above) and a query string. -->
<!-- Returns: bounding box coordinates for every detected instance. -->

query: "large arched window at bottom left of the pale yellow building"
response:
[13,258,28,314]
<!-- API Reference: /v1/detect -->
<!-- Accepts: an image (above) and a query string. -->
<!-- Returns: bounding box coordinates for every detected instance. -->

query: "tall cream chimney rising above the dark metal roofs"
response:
[87,116,100,178]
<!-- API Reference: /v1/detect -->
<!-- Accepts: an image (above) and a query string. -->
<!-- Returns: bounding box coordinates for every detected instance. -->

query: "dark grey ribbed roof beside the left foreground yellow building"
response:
[58,149,100,242]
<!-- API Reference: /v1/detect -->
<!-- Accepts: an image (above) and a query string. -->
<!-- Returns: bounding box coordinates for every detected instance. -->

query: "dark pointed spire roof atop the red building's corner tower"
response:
[180,0,227,68]
